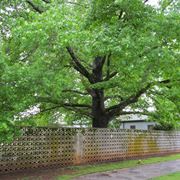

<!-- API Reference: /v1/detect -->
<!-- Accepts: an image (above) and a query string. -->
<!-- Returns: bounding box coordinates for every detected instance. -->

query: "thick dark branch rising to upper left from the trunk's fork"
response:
[66,47,94,83]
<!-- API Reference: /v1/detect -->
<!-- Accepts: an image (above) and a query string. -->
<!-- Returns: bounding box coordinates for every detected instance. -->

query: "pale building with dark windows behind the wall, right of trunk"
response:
[120,115,156,130]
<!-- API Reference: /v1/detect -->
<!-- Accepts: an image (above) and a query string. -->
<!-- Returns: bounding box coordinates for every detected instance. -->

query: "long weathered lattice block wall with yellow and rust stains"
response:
[0,128,180,173]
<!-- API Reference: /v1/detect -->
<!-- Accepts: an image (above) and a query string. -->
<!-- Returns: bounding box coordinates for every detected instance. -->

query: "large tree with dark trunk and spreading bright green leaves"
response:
[0,0,180,128]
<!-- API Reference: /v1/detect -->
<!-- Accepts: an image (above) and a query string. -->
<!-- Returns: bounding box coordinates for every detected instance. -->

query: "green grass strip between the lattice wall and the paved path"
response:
[58,154,180,180]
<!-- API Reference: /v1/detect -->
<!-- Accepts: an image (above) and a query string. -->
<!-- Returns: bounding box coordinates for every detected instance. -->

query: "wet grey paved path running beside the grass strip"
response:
[76,160,180,180]
